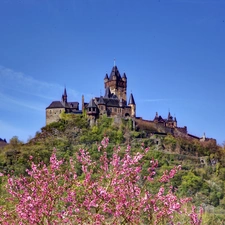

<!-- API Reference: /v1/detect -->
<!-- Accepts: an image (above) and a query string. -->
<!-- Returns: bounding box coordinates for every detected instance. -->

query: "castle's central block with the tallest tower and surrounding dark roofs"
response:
[87,66,136,125]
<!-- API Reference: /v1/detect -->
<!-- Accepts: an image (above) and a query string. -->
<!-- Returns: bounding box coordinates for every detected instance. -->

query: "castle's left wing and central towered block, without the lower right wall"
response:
[46,66,136,125]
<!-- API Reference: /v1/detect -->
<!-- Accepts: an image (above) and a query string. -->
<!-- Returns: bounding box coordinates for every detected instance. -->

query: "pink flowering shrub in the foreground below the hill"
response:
[0,138,201,225]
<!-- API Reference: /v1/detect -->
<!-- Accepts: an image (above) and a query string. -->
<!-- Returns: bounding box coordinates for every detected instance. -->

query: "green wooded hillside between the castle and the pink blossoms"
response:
[0,114,225,224]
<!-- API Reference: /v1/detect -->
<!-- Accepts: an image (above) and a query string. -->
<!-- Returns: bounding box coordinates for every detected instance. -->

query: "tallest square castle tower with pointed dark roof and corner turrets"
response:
[104,66,127,103]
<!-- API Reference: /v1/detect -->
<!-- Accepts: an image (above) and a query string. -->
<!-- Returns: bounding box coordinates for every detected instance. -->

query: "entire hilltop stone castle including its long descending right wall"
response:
[46,65,213,141]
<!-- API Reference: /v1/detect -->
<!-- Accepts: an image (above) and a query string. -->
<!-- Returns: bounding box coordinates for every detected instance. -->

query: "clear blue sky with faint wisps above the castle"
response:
[0,0,225,144]
